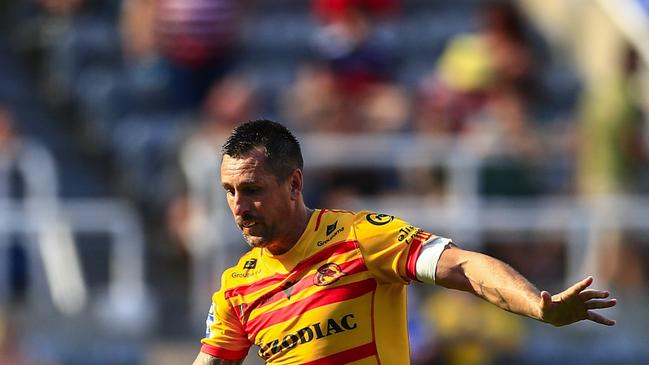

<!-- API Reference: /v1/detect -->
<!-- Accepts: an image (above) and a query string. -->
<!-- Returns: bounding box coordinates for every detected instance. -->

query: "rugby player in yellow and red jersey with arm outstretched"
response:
[194,120,616,365]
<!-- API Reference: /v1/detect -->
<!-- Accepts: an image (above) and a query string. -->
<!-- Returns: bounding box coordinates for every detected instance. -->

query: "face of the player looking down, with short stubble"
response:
[221,149,294,247]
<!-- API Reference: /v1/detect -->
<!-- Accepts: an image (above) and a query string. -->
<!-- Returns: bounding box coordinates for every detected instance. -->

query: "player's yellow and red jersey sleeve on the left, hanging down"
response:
[201,275,252,360]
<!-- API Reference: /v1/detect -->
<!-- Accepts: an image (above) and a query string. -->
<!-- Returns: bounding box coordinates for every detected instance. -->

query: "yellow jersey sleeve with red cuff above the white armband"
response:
[354,211,436,284]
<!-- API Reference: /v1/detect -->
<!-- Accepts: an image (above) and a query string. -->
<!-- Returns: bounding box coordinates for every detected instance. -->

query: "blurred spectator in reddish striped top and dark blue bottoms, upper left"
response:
[120,0,241,113]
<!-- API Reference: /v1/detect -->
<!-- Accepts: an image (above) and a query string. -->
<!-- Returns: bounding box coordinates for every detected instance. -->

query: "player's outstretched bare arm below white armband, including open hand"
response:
[435,246,616,326]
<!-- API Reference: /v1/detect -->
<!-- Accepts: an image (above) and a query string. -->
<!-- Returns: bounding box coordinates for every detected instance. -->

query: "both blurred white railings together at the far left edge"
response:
[0,139,148,329]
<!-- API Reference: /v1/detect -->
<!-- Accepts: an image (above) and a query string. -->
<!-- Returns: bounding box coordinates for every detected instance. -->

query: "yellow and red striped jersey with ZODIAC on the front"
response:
[201,209,432,365]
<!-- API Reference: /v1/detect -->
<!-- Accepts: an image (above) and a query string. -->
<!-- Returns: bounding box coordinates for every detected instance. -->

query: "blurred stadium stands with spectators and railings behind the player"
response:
[0,0,649,365]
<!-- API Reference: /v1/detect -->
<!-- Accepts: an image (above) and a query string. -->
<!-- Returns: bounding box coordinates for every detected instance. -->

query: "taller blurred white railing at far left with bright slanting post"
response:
[0,138,87,314]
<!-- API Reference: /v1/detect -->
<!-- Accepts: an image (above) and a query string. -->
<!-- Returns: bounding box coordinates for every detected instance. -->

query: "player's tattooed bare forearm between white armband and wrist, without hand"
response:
[439,249,541,319]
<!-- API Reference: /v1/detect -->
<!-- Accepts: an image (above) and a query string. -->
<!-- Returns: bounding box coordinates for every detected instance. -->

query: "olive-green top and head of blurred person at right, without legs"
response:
[578,47,647,197]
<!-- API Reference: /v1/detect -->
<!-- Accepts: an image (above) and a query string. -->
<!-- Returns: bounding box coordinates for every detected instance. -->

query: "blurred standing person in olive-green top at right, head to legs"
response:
[577,46,647,287]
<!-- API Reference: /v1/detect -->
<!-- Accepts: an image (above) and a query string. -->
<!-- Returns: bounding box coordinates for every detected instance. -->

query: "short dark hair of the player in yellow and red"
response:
[221,119,304,179]
